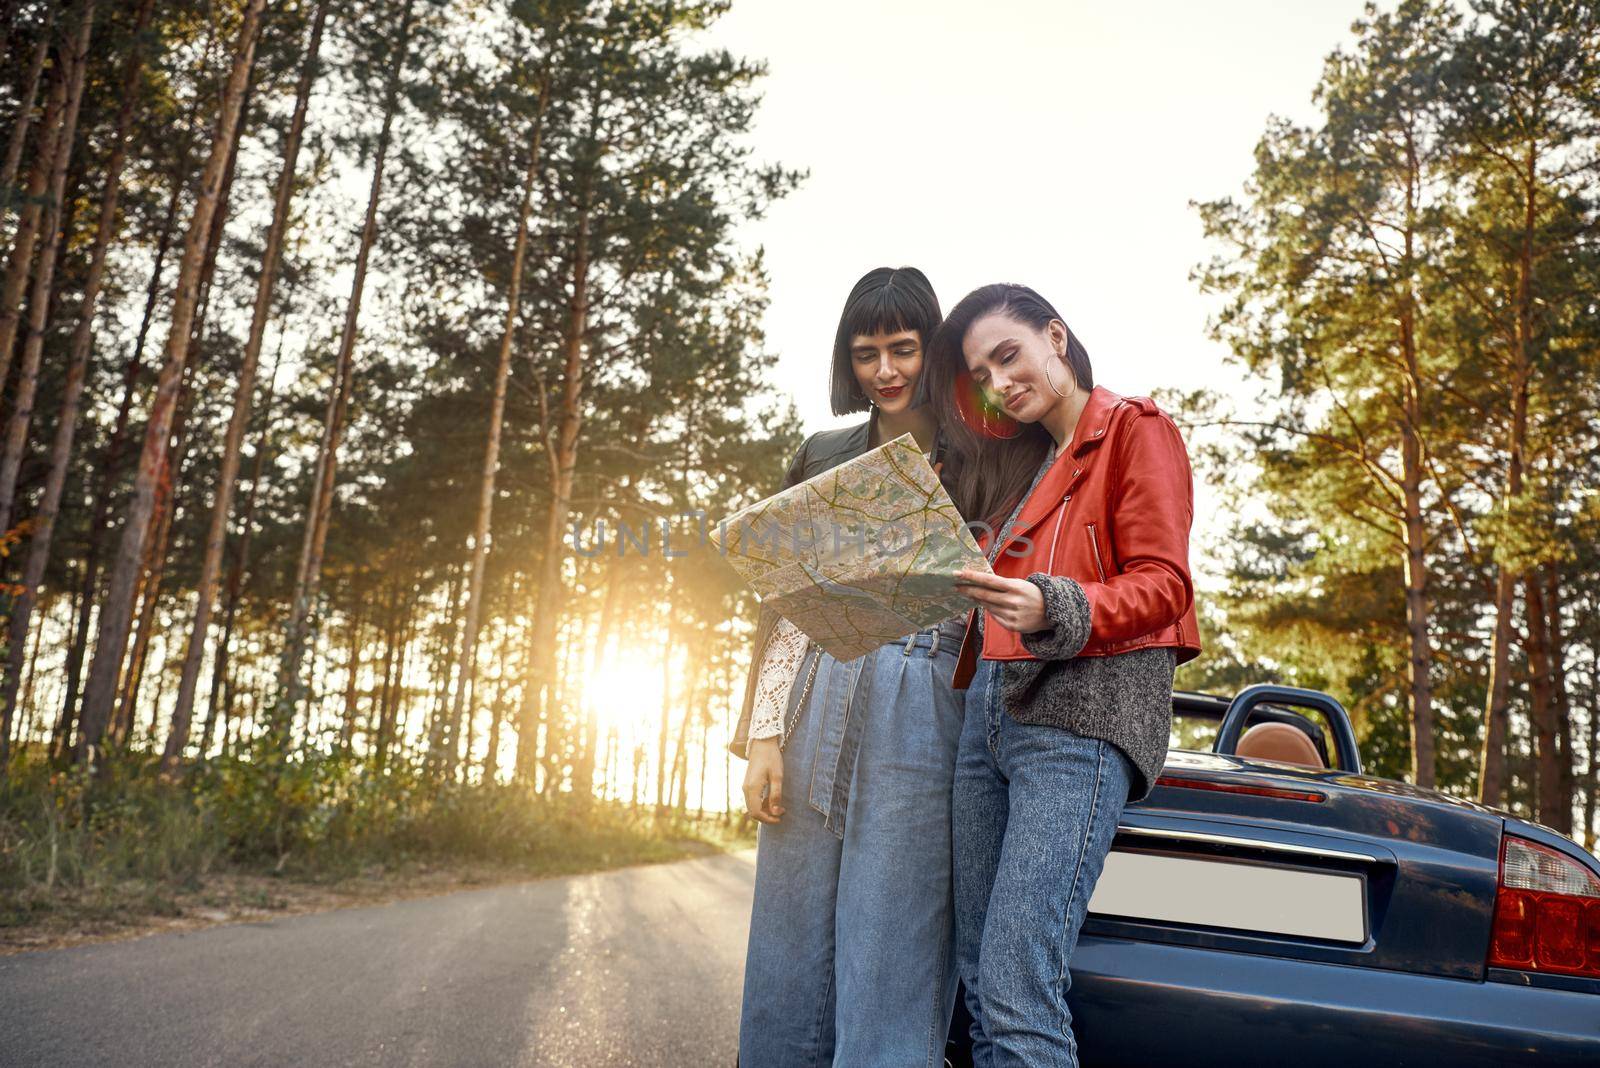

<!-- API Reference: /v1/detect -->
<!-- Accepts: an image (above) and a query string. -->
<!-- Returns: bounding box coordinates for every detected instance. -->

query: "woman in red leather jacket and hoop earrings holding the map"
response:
[925,285,1200,1068]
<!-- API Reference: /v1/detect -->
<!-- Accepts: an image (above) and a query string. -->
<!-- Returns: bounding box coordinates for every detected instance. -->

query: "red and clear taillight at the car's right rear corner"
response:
[1488,835,1600,978]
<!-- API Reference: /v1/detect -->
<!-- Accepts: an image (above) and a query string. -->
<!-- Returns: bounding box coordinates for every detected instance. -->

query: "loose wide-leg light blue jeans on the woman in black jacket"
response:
[739,628,963,1068]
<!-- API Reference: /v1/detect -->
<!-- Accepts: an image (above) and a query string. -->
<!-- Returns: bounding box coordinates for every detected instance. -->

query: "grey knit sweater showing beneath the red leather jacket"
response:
[978,449,1178,801]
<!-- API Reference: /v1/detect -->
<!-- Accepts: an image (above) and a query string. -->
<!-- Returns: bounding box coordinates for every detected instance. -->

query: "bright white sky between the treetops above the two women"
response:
[712,0,1363,585]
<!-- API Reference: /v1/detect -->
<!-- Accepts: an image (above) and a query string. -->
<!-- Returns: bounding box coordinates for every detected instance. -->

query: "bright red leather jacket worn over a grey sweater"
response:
[952,385,1200,689]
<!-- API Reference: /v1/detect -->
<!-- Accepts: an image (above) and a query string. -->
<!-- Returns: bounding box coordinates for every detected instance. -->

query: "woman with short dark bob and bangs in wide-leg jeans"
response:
[730,267,965,1068]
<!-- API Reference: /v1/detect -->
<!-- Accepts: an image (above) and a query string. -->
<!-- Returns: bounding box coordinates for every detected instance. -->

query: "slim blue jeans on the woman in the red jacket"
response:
[954,660,1133,1068]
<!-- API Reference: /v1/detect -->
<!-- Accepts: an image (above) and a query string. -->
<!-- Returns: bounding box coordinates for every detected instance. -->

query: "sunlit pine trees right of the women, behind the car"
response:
[1190,0,1600,849]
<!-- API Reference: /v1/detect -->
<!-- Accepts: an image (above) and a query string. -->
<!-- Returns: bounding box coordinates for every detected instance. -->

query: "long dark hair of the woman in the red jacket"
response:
[918,283,1094,531]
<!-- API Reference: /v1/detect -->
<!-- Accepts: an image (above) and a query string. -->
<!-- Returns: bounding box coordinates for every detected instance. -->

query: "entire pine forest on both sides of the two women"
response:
[0,0,1600,923]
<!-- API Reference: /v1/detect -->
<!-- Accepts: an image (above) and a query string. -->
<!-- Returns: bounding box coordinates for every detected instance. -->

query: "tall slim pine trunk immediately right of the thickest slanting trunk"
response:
[162,0,330,771]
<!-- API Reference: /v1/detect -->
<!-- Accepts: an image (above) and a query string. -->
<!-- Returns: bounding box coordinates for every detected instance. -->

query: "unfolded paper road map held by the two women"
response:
[710,433,990,660]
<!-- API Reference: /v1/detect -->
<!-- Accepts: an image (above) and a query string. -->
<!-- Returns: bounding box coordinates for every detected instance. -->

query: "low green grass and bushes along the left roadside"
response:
[0,751,738,926]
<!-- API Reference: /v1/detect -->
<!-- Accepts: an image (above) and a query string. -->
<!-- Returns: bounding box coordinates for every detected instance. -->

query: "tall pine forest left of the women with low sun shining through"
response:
[0,0,800,920]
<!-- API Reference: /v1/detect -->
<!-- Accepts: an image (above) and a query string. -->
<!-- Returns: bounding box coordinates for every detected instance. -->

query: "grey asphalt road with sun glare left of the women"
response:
[0,852,755,1068]
